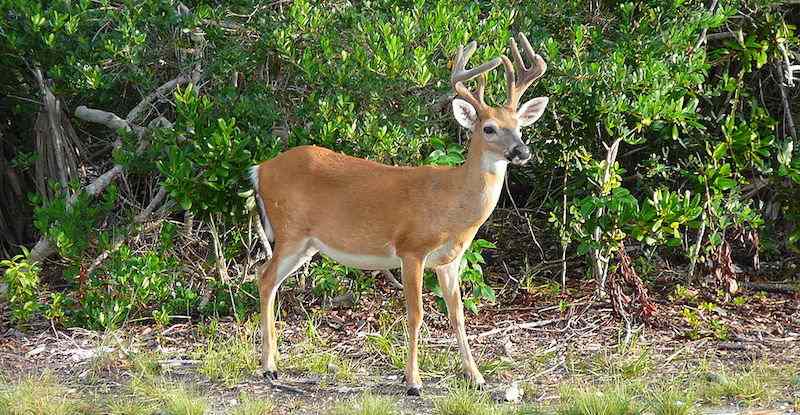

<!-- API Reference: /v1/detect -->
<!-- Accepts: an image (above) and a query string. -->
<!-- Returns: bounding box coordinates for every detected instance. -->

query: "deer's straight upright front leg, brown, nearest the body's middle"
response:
[403,258,424,396]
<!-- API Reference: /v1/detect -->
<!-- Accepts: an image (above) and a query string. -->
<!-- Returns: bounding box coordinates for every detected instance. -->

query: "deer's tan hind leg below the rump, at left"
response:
[258,243,316,379]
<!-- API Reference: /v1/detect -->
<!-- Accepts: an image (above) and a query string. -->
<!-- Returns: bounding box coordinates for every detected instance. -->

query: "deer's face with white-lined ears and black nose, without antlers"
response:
[453,97,548,165]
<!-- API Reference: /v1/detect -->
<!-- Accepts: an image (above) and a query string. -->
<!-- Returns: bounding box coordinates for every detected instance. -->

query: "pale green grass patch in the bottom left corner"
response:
[0,373,97,415]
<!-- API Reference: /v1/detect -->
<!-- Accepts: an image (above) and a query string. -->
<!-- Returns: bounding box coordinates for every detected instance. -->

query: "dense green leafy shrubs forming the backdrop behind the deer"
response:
[0,0,800,327]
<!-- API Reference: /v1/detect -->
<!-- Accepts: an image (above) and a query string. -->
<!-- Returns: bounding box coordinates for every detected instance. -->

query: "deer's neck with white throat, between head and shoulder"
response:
[460,134,508,225]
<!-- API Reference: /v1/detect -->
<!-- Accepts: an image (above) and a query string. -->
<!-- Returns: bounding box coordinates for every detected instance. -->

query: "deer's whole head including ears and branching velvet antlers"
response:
[450,33,548,165]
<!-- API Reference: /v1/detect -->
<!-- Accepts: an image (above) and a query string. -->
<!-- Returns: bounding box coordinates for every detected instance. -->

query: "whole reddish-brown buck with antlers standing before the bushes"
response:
[251,33,548,395]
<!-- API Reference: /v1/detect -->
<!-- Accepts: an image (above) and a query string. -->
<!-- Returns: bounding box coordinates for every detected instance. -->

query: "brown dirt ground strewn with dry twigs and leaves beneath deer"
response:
[0,274,800,414]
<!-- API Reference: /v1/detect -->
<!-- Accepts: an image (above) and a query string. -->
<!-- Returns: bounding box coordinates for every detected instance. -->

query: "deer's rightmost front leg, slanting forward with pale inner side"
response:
[436,257,485,386]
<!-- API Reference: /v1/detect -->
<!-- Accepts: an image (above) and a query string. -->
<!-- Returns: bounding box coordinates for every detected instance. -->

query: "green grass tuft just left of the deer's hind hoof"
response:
[193,330,259,387]
